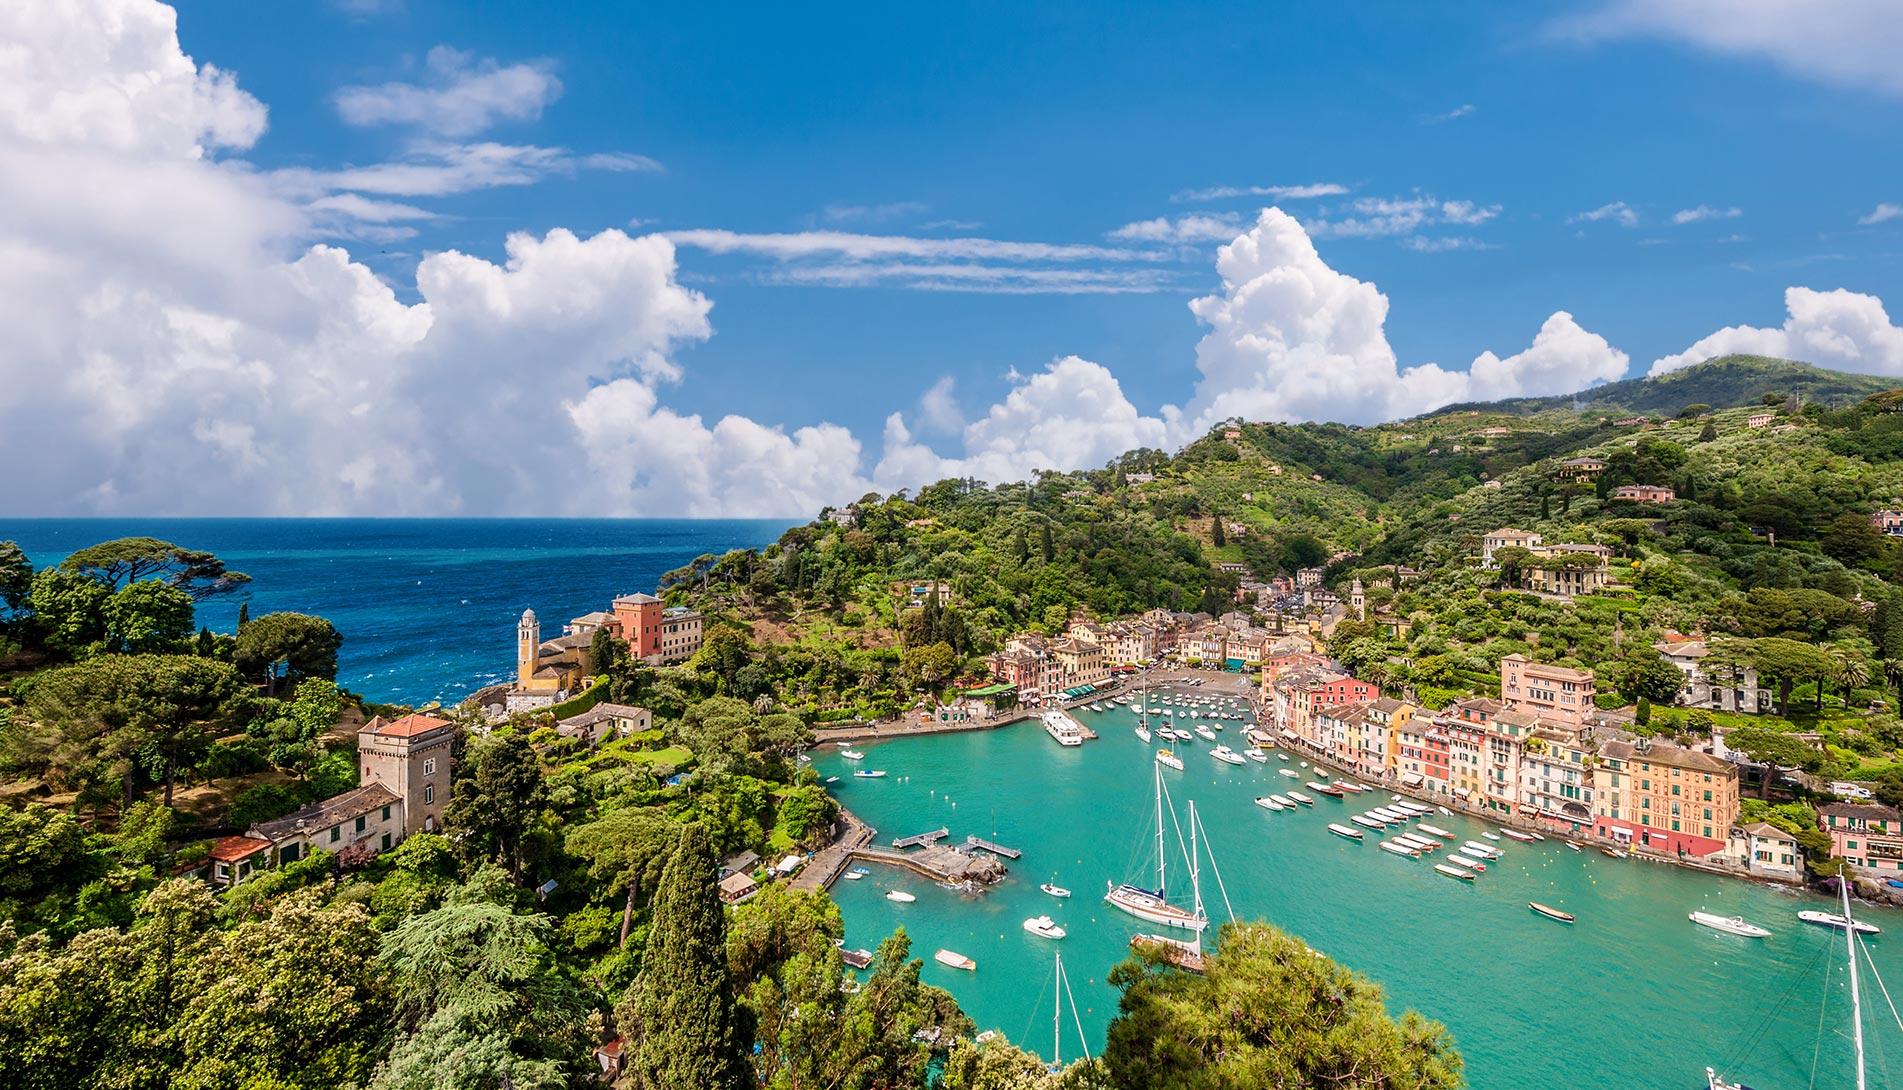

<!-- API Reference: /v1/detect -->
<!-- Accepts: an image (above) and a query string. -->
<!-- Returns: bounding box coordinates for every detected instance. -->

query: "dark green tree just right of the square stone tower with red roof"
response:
[443,730,548,881]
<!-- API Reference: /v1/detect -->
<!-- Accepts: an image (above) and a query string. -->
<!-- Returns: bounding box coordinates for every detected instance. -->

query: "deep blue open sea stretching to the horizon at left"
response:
[0,519,792,704]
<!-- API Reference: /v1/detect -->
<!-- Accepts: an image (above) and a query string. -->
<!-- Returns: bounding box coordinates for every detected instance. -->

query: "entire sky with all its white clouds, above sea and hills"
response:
[0,0,1903,517]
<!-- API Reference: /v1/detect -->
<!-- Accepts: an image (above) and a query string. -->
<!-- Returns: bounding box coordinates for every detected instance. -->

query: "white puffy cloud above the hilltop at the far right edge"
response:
[1650,287,1903,375]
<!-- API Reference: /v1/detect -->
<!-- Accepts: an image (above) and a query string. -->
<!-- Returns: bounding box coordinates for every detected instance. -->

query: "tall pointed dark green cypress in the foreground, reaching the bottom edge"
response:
[630,822,752,1090]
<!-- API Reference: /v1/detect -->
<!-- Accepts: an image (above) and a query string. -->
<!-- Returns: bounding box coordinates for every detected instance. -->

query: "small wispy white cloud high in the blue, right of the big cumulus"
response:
[335,46,561,137]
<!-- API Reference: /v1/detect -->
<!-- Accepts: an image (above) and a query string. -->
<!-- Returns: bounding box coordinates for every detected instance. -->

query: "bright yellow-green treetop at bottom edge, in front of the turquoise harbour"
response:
[1102,923,1463,1090]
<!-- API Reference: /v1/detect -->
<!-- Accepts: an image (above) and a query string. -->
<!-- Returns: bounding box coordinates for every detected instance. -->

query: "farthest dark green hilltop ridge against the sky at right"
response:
[1431,356,1895,417]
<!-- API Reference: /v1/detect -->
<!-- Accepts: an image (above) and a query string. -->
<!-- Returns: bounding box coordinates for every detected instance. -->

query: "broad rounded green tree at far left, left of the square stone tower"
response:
[25,654,255,807]
